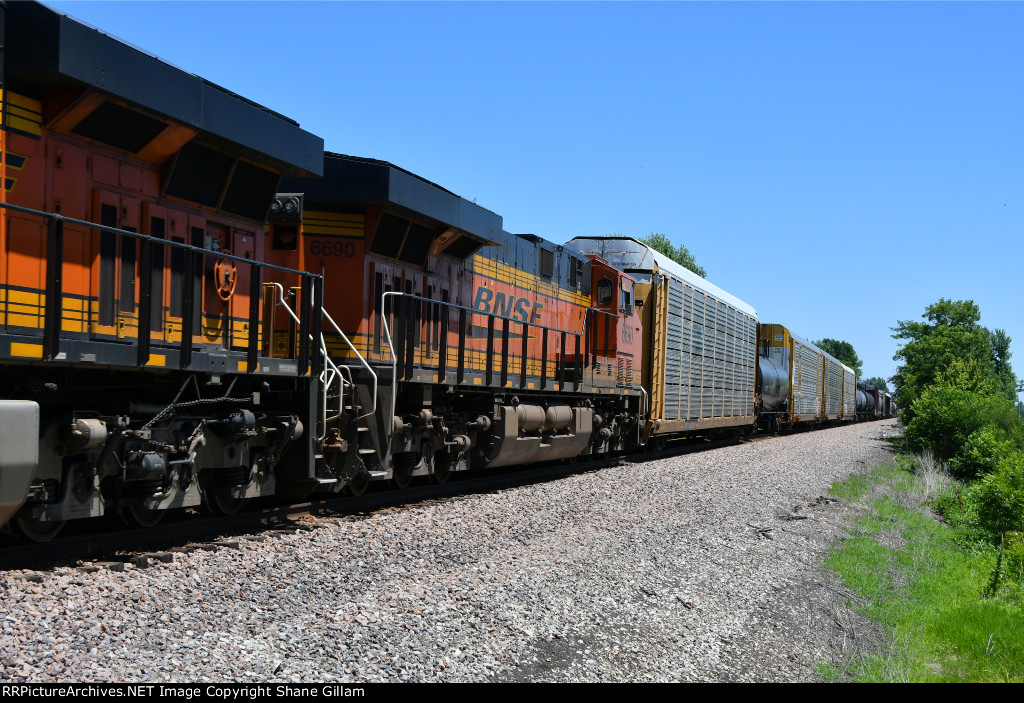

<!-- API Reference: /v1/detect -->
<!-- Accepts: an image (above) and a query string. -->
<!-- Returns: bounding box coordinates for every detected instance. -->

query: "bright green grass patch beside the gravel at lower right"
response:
[817,462,1024,682]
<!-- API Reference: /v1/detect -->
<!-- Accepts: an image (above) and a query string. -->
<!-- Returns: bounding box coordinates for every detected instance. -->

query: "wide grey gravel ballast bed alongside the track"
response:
[0,421,897,683]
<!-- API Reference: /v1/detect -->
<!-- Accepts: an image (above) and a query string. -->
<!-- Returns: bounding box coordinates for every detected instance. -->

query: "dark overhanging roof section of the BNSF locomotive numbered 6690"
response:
[282,151,502,244]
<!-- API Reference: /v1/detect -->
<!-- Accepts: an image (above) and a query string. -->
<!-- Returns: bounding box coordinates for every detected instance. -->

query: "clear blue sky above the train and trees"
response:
[48,2,1024,390]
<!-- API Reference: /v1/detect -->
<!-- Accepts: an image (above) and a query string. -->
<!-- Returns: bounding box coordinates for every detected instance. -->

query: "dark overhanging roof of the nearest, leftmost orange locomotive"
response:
[3,2,324,176]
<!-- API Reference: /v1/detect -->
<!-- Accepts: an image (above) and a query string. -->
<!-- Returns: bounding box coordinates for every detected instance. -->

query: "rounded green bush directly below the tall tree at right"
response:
[906,385,1017,468]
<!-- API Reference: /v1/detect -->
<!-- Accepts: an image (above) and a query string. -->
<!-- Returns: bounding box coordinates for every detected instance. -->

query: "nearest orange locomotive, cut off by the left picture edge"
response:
[0,3,323,539]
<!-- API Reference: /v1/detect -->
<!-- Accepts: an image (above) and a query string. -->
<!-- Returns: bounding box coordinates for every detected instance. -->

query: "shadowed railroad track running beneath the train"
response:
[0,436,768,578]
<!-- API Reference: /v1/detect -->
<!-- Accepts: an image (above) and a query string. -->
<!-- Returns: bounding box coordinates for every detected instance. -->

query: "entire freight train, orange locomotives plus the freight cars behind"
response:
[0,3,895,540]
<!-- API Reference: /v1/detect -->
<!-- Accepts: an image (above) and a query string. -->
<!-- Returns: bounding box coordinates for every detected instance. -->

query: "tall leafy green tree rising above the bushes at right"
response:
[891,298,1016,423]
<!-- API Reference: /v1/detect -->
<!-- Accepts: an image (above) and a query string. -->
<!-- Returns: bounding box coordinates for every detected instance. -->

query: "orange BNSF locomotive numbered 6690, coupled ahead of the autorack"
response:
[266,153,642,492]
